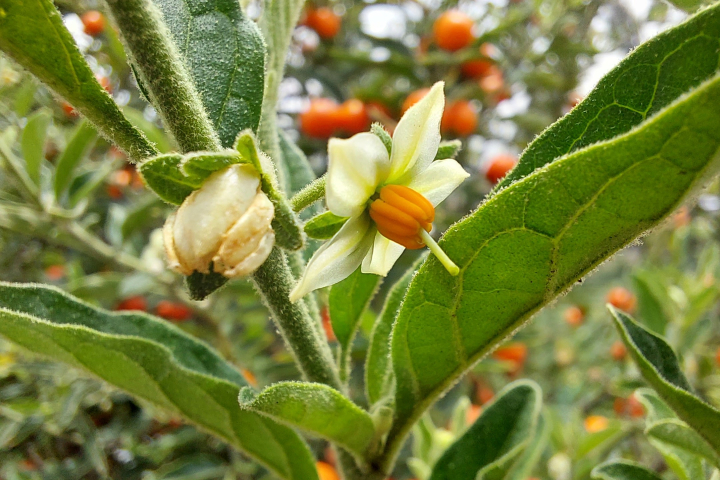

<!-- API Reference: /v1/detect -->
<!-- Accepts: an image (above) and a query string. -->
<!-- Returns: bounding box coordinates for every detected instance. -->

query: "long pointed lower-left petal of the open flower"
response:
[290,215,376,302]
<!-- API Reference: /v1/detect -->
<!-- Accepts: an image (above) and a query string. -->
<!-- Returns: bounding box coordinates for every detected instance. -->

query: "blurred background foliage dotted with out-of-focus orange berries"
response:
[0,0,720,480]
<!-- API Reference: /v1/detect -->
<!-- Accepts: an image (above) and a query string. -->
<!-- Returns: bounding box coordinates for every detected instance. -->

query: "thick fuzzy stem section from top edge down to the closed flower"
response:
[102,0,220,152]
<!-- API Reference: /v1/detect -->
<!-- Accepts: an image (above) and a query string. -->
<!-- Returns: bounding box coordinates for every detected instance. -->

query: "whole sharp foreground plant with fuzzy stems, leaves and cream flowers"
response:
[0,0,720,480]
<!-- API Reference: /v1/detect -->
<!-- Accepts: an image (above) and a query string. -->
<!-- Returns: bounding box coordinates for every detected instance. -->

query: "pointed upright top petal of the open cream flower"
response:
[387,82,445,183]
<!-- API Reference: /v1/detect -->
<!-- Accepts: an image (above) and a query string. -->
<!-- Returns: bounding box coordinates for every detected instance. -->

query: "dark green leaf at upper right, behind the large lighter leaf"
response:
[494,4,720,192]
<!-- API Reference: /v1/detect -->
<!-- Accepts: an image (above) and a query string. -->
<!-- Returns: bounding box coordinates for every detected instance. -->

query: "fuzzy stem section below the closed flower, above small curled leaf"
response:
[253,247,342,390]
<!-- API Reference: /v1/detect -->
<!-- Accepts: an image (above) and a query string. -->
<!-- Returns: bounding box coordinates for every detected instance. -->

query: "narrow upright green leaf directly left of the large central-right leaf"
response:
[365,256,425,405]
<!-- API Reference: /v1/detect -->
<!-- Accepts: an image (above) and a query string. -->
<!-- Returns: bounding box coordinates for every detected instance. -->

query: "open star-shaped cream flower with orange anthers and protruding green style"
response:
[290,82,469,301]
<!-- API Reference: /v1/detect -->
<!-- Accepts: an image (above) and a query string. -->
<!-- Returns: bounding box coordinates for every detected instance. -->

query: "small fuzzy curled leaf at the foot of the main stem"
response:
[240,382,375,457]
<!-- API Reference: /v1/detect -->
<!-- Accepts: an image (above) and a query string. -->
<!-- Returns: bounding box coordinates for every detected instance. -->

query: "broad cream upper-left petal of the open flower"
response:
[325,132,390,217]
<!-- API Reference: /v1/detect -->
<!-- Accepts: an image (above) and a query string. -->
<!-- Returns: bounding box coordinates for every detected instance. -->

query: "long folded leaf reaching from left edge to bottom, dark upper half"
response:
[0,283,317,480]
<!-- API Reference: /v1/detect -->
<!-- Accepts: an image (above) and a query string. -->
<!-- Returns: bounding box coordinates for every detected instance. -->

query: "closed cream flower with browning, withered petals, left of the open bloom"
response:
[163,165,275,278]
